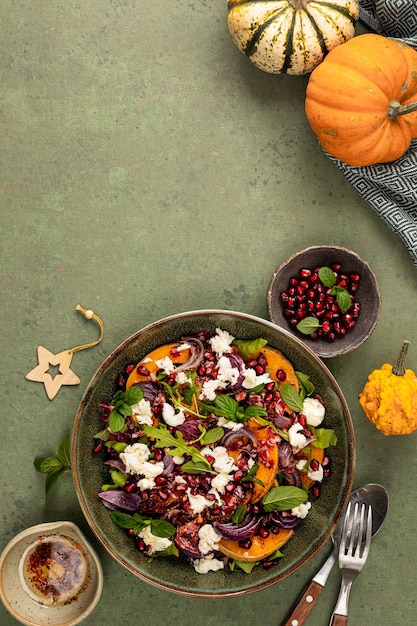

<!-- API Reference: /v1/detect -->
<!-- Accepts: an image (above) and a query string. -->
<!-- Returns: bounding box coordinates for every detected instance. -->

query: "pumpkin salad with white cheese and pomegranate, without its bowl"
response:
[95,328,337,574]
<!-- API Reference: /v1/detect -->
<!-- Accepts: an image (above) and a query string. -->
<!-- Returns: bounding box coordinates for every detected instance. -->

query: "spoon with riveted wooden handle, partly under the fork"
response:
[282,483,388,626]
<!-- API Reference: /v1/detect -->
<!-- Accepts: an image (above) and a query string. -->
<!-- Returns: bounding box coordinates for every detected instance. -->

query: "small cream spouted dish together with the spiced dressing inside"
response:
[0,522,103,626]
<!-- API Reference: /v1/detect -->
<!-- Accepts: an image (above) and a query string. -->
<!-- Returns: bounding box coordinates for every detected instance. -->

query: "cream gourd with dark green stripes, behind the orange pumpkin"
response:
[227,0,359,74]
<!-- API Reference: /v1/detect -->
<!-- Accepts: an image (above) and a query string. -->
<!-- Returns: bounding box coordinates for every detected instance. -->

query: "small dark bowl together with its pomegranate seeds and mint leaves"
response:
[267,246,381,358]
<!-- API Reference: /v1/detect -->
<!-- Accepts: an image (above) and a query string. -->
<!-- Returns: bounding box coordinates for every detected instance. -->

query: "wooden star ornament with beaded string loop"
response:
[25,304,104,400]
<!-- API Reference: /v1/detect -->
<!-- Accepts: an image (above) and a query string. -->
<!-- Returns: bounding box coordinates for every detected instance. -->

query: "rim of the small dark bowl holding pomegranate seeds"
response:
[266,244,381,359]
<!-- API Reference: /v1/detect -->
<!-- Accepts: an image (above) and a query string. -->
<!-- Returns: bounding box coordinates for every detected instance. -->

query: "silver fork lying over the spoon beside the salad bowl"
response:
[330,502,372,626]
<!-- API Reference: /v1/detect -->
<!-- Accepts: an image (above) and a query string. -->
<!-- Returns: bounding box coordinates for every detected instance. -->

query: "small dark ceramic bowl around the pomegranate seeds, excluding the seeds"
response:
[267,246,381,358]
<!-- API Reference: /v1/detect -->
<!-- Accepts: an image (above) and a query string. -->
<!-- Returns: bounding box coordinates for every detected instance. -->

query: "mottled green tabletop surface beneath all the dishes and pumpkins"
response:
[0,0,417,626]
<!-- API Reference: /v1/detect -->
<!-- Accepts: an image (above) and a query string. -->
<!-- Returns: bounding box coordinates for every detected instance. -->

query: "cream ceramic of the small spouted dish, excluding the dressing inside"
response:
[0,522,103,626]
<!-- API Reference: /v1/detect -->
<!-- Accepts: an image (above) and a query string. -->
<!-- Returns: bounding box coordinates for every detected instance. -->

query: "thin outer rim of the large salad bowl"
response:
[71,309,356,598]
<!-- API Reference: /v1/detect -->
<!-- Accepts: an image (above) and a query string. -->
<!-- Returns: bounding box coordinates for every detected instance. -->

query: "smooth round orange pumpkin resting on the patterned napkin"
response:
[305,33,417,166]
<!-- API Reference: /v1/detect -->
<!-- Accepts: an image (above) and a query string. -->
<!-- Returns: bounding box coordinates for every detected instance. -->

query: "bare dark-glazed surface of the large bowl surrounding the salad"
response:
[72,310,355,597]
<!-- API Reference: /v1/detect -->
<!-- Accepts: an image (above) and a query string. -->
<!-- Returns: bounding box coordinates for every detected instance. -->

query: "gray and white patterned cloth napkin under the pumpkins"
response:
[330,0,417,267]
